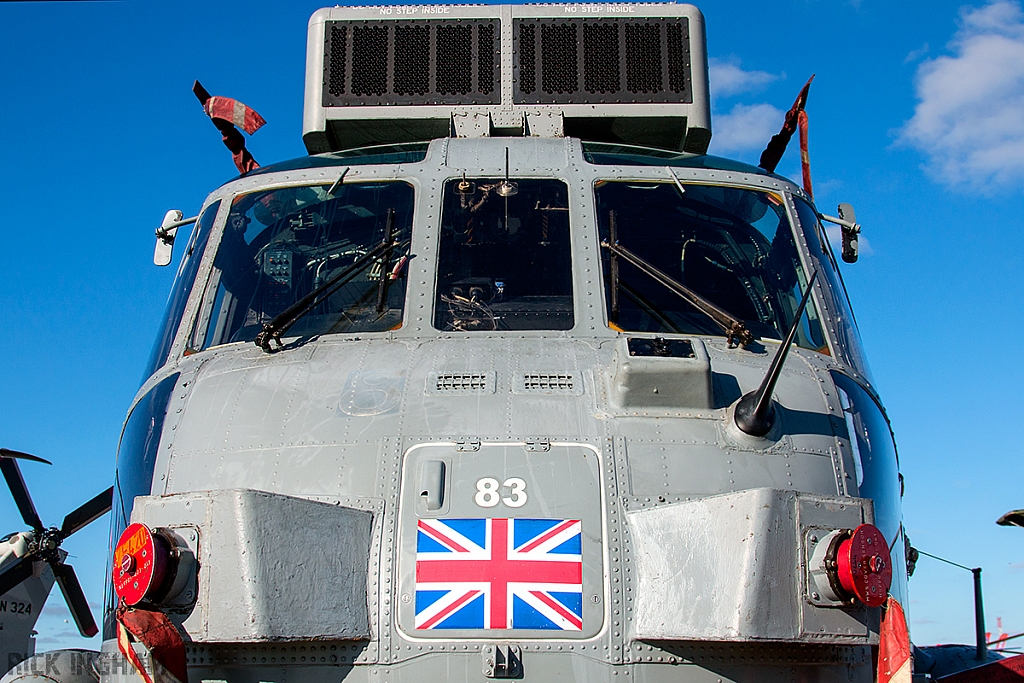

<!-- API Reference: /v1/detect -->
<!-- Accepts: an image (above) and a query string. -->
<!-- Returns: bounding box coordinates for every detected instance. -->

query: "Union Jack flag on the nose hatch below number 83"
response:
[416,518,583,631]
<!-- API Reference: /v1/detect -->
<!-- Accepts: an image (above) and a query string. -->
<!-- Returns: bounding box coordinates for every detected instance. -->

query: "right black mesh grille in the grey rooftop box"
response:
[513,17,693,104]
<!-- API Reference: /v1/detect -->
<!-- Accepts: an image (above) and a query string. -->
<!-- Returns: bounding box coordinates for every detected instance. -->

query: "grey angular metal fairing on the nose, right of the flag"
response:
[627,488,877,643]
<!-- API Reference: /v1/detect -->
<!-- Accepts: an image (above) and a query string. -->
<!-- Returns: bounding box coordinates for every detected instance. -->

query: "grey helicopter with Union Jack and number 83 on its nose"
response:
[0,4,958,681]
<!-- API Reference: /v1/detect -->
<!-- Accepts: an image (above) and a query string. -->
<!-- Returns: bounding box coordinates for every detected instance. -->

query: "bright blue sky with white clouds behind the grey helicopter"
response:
[0,0,1024,649]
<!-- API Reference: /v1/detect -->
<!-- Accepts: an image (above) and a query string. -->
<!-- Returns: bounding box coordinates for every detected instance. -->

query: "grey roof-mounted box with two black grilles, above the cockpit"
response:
[302,3,711,154]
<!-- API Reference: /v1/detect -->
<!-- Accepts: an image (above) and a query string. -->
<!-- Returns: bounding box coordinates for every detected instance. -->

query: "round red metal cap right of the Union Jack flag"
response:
[836,524,893,607]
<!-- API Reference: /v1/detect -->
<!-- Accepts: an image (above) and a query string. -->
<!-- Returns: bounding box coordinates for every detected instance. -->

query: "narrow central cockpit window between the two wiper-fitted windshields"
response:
[434,178,573,332]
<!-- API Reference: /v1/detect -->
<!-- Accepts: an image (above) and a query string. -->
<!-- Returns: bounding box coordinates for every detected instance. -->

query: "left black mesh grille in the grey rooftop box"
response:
[323,19,501,106]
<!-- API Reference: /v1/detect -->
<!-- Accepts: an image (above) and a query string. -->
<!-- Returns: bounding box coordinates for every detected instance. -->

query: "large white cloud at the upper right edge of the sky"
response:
[899,0,1024,190]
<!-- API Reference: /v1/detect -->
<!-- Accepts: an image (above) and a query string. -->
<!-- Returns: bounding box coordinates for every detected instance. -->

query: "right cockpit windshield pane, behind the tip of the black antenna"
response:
[596,181,826,350]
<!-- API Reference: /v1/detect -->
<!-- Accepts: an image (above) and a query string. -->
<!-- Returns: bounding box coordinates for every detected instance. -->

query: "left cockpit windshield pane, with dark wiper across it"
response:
[191,181,413,349]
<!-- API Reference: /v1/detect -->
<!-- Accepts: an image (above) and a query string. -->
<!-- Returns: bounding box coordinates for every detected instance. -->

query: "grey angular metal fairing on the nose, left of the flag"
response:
[132,489,372,643]
